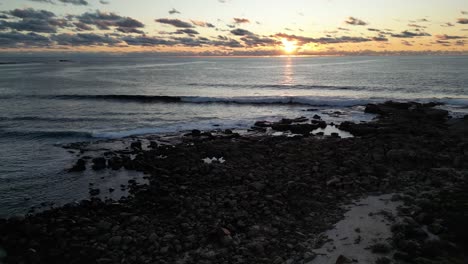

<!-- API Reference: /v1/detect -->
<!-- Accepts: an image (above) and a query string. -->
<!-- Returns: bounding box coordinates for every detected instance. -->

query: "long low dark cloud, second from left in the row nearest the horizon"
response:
[51,33,121,46]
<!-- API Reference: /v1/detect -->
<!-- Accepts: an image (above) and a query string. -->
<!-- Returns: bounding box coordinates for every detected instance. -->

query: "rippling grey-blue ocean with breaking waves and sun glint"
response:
[0,55,468,216]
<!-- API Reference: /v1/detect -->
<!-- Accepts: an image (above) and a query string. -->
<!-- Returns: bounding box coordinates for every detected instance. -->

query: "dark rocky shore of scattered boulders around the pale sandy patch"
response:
[0,102,468,264]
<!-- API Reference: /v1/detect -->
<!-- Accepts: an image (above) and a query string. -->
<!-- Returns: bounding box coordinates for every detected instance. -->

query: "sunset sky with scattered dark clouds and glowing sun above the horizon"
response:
[0,0,468,55]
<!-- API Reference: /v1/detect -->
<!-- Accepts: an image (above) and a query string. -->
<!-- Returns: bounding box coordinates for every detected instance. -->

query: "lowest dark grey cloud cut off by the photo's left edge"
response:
[0,31,51,48]
